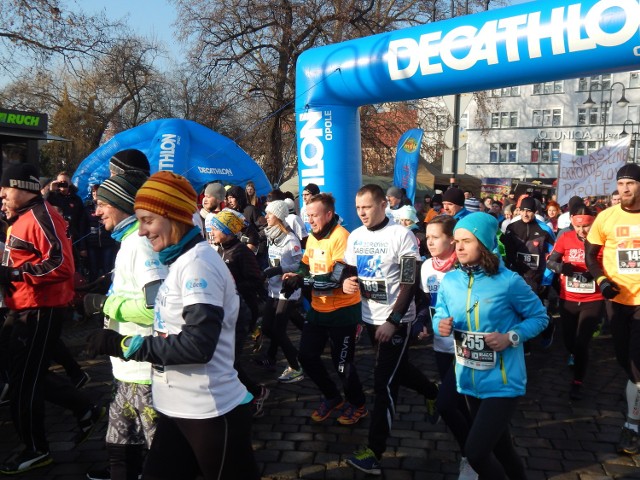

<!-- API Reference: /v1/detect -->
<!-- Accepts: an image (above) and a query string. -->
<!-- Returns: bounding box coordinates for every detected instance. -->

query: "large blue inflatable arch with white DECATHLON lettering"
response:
[295,0,640,230]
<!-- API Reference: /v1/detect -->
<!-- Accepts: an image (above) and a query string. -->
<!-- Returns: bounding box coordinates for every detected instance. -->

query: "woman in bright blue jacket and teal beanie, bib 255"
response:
[433,212,548,480]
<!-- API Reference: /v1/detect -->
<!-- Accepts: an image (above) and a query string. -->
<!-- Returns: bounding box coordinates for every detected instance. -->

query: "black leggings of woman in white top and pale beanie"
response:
[262,298,300,370]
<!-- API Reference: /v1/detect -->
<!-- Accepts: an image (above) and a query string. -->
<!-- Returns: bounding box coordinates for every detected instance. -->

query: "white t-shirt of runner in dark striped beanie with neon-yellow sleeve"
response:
[107,230,167,382]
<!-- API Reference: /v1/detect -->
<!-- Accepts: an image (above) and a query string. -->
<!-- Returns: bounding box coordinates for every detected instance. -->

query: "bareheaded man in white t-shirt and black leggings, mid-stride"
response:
[343,184,438,475]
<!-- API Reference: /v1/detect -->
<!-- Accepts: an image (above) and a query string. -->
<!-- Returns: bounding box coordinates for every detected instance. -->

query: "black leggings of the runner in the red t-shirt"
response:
[560,300,604,382]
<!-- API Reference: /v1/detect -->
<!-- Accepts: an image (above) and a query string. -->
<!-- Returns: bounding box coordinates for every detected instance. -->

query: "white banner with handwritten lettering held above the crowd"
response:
[557,135,631,205]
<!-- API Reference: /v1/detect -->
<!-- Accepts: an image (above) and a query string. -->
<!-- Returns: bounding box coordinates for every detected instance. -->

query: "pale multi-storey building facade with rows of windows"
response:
[460,71,640,183]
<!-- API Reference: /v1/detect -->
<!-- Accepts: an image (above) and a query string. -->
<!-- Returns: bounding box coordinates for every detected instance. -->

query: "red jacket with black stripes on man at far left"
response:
[2,197,75,310]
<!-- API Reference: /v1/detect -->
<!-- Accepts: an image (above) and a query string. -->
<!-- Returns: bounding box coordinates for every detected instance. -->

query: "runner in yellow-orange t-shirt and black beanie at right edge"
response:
[585,163,640,455]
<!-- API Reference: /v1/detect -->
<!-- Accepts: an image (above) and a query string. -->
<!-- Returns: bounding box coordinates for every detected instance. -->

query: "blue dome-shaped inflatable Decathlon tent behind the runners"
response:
[72,118,272,198]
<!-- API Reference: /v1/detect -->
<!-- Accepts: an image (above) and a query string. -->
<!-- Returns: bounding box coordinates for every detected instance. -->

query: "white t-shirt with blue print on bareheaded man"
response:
[344,223,420,325]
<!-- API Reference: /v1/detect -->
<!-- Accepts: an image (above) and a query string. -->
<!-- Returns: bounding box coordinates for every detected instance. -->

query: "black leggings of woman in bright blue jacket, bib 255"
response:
[465,395,527,480]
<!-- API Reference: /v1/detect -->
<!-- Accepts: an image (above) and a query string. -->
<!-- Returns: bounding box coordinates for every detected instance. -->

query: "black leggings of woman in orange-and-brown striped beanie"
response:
[142,404,260,480]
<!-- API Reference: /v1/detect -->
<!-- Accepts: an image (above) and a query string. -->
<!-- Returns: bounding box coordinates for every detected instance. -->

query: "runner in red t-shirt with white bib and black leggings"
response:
[547,204,604,400]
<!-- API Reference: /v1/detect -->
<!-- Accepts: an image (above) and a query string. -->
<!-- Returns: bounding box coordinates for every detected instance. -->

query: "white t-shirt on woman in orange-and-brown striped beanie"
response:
[153,242,247,418]
